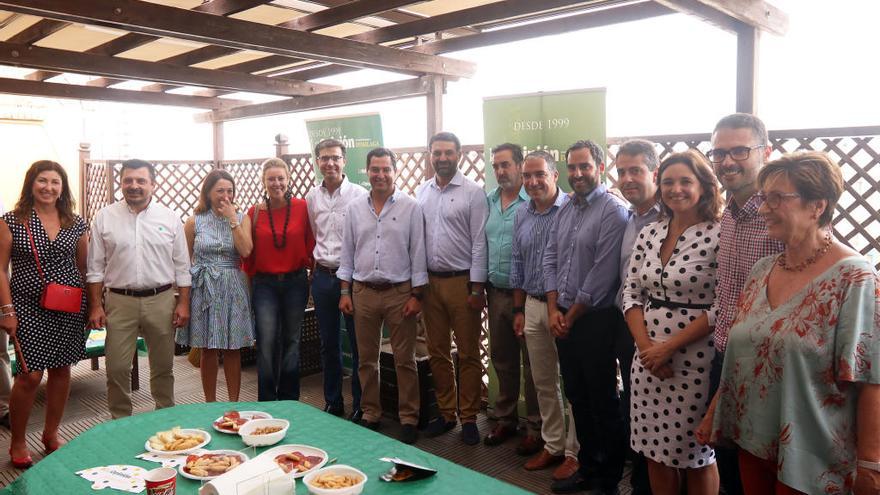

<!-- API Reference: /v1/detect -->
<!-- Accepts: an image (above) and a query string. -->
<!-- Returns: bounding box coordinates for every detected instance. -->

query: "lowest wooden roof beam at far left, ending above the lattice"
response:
[0,78,248,109]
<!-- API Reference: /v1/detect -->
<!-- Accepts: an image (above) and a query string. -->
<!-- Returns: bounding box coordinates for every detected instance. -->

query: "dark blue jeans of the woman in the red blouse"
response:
[253,270,309,401]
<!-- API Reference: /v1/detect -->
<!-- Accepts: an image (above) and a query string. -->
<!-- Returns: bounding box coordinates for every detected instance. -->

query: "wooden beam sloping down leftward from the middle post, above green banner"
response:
[195,78,429,122]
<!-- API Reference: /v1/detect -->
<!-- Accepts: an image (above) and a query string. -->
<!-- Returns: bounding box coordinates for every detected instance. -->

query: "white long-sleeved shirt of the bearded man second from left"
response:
[86,200,192,290]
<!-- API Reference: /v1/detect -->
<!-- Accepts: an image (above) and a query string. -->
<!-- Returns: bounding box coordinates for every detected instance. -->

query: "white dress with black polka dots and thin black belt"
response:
[623,220,720,468]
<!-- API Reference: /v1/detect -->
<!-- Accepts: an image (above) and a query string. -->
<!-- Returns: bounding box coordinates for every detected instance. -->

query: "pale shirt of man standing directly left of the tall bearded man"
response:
[336,190,428,287]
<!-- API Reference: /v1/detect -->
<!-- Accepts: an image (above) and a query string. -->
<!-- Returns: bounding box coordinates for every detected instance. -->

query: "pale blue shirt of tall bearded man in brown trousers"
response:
[416,170,489,283]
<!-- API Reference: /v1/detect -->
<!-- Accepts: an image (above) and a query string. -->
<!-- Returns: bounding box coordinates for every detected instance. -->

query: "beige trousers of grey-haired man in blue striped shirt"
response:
[524,297,580,458]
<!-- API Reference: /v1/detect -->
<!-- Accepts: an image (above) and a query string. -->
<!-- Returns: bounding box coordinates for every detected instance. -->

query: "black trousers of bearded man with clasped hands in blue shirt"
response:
[556,307,626,489]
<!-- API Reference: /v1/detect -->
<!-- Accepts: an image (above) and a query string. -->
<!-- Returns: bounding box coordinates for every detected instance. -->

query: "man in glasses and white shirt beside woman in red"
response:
[306,139,367,422]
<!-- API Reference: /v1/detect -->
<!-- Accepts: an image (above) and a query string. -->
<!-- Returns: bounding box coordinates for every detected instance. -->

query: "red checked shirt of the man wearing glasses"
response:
[708,195,784,352]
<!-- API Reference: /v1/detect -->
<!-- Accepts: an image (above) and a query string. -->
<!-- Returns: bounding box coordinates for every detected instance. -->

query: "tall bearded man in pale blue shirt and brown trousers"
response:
[416,132,489,445]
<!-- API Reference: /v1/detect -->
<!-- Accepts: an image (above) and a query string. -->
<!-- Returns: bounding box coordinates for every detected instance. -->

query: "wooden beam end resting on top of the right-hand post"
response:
[655,0,788,35]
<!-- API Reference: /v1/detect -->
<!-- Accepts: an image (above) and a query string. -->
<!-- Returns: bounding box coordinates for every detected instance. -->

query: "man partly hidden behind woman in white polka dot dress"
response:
[615,139,660,495]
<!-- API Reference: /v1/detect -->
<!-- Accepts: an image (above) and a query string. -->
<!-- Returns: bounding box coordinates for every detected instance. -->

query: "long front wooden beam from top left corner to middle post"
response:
[0,0,475,77]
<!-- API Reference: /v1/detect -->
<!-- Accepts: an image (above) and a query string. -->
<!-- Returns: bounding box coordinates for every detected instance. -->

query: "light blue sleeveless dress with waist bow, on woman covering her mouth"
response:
[176,211,254,349]
